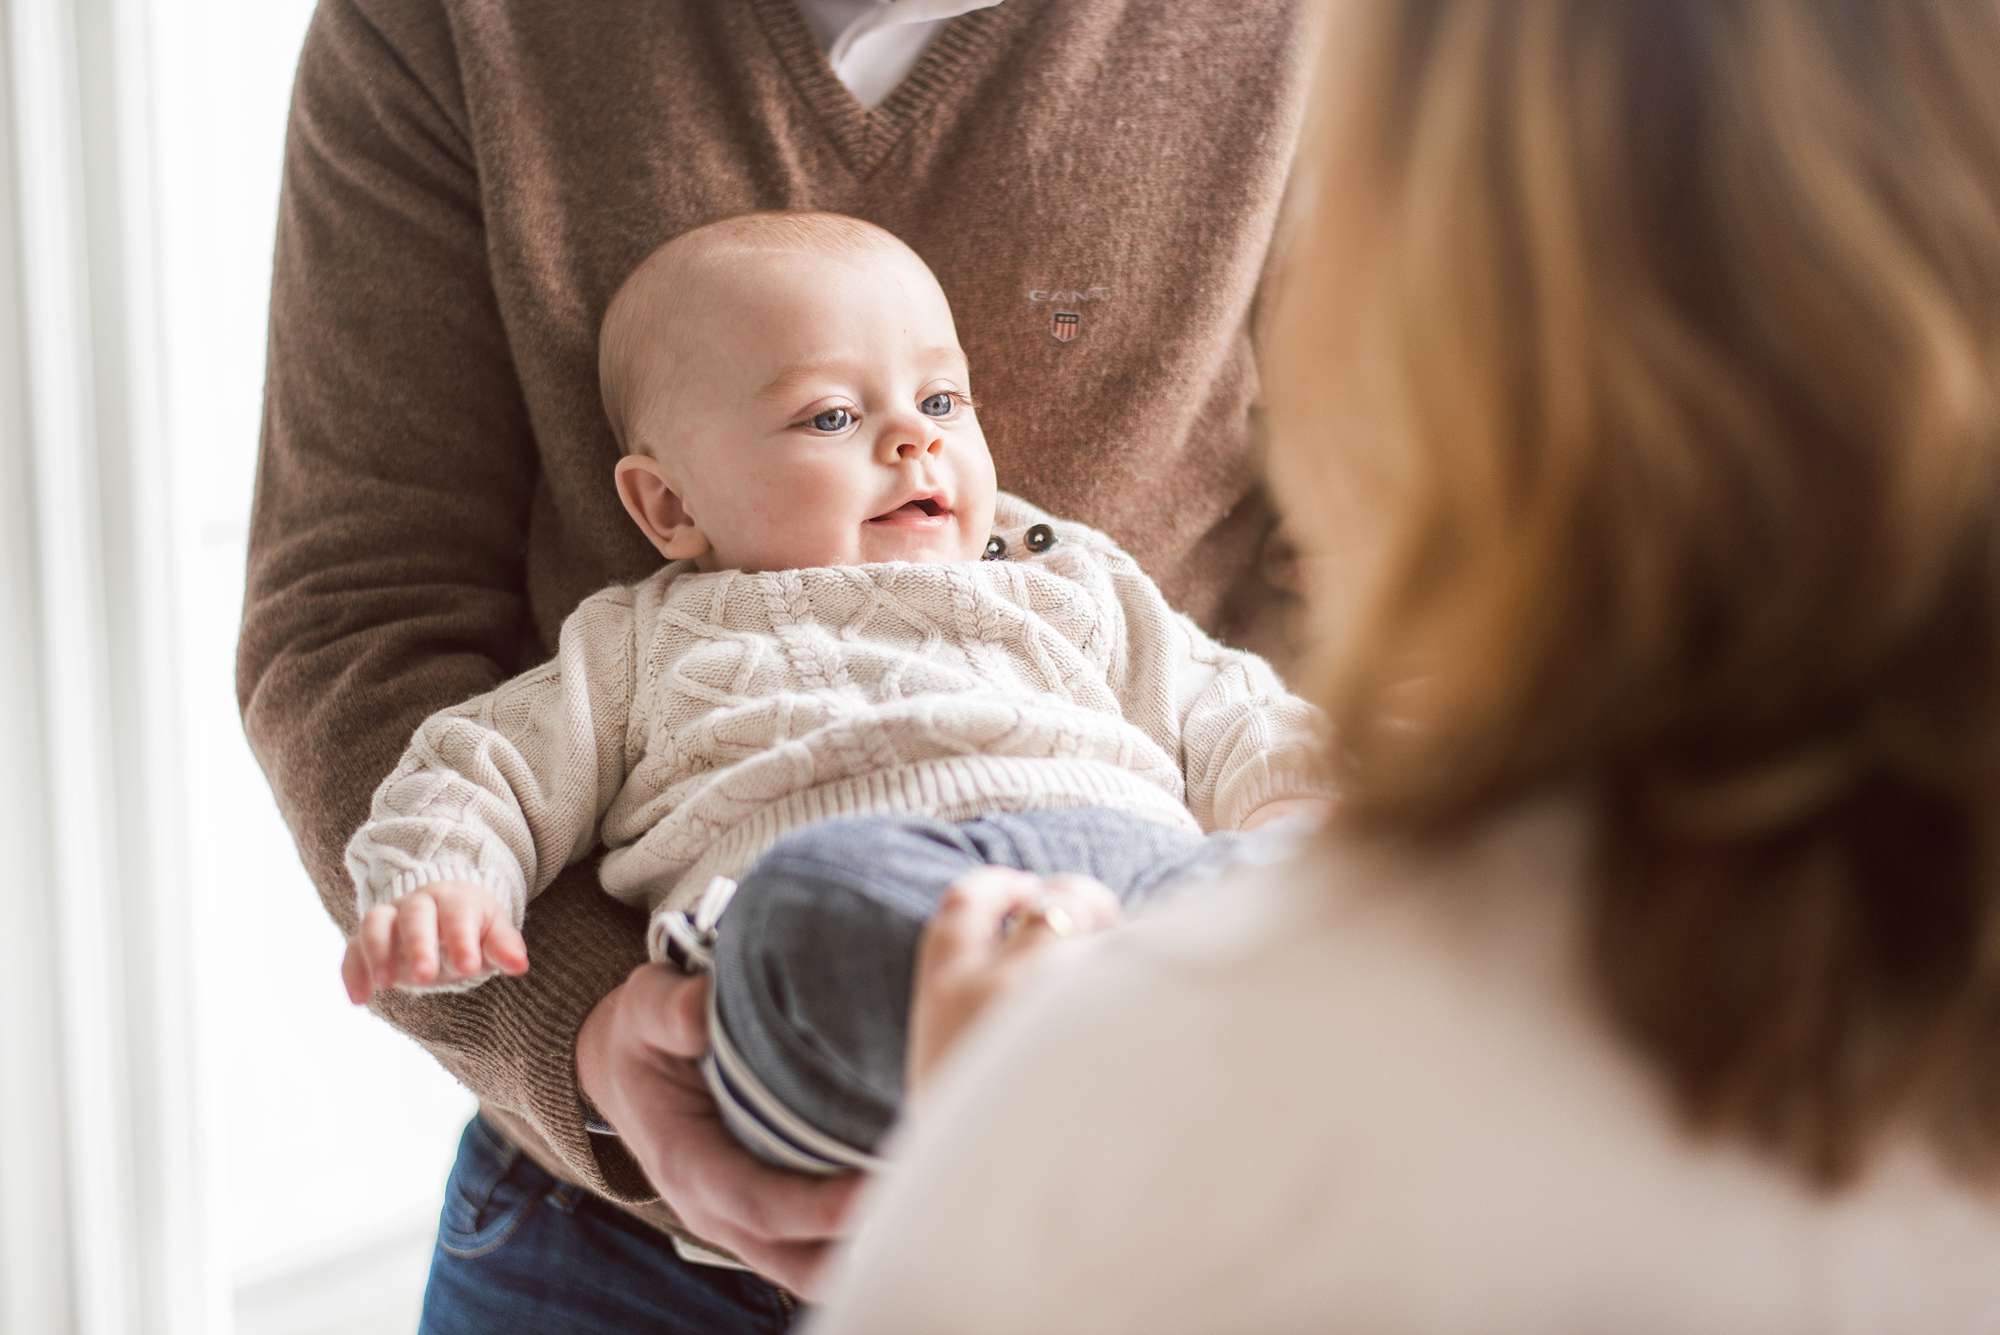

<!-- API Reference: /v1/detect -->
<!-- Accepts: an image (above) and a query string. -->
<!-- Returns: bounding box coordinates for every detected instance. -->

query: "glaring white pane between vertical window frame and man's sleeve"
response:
[154,0,470,1283]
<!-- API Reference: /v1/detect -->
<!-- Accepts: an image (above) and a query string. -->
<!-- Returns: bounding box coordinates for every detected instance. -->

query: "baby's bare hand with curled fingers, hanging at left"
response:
[340,881,528,1005]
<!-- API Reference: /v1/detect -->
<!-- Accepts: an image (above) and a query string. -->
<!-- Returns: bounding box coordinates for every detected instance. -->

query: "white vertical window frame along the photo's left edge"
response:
[0,0,228,1335]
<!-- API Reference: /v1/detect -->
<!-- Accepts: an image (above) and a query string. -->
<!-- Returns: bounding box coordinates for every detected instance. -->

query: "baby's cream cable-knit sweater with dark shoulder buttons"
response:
[346,496,1332,983]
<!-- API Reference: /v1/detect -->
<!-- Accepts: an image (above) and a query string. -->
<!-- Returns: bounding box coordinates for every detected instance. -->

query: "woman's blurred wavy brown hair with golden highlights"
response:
[1272,0,2000,1183]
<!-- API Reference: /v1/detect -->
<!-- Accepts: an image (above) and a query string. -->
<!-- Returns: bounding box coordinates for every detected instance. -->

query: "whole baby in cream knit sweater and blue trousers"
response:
[344,214,1330,1171]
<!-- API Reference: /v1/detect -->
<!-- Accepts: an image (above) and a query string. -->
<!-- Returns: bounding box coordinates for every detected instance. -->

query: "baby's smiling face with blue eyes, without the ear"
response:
[628,246,994,570]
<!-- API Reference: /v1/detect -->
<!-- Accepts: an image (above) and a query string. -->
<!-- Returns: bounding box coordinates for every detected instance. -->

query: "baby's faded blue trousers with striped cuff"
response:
[702,807,1244,1173]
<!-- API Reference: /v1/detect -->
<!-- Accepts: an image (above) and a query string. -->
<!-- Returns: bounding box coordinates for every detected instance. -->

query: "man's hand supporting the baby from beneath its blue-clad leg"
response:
[576,963,862,1301]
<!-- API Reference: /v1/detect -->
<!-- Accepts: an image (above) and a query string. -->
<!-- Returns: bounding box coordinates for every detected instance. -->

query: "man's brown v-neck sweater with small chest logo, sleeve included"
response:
[238,0,1306,1223]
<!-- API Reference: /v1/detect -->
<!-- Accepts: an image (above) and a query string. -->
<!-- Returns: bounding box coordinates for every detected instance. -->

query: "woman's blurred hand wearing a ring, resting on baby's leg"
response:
[904,867,1118,1101]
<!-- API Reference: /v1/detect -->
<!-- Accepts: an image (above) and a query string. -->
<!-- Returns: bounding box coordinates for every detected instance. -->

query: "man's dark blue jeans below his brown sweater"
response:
[418,1117,796,1335]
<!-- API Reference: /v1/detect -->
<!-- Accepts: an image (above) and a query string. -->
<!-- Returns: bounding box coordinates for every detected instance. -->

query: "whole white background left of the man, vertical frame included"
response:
[0,0,472,1335]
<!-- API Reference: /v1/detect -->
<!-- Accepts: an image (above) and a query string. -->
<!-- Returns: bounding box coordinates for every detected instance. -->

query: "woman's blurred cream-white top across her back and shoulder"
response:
[810,805,2000,1335]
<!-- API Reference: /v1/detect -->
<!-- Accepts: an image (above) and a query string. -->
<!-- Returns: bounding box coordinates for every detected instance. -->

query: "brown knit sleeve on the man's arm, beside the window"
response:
[236,0,652,1201]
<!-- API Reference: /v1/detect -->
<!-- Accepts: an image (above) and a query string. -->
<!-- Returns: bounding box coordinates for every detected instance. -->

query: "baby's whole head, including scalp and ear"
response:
[598,214,994,570]
